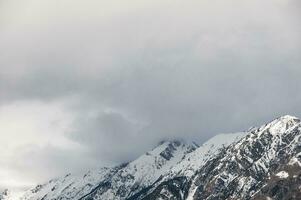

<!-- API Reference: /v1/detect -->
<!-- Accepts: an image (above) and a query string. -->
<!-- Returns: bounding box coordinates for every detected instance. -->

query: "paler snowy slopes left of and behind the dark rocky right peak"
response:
[17,133,244,200]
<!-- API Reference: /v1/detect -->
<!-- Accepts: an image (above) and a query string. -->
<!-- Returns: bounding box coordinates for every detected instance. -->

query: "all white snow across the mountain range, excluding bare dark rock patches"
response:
[13,115,301,200]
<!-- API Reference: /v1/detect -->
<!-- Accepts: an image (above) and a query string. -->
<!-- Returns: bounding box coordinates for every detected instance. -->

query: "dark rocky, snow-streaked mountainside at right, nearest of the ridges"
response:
[137,116,301,200]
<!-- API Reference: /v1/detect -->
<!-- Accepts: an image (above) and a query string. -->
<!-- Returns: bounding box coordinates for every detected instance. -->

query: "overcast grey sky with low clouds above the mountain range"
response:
[0,0,301,191]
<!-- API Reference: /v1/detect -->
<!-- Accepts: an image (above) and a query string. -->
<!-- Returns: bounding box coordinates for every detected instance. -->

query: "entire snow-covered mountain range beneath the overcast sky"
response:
[5,115,301,200]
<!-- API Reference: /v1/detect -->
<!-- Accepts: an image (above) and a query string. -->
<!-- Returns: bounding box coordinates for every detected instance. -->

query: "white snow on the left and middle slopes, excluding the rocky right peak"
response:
[14,133,245,200]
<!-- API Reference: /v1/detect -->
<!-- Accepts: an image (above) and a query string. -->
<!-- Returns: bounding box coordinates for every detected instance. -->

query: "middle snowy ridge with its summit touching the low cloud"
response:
[79,141,196,200]
